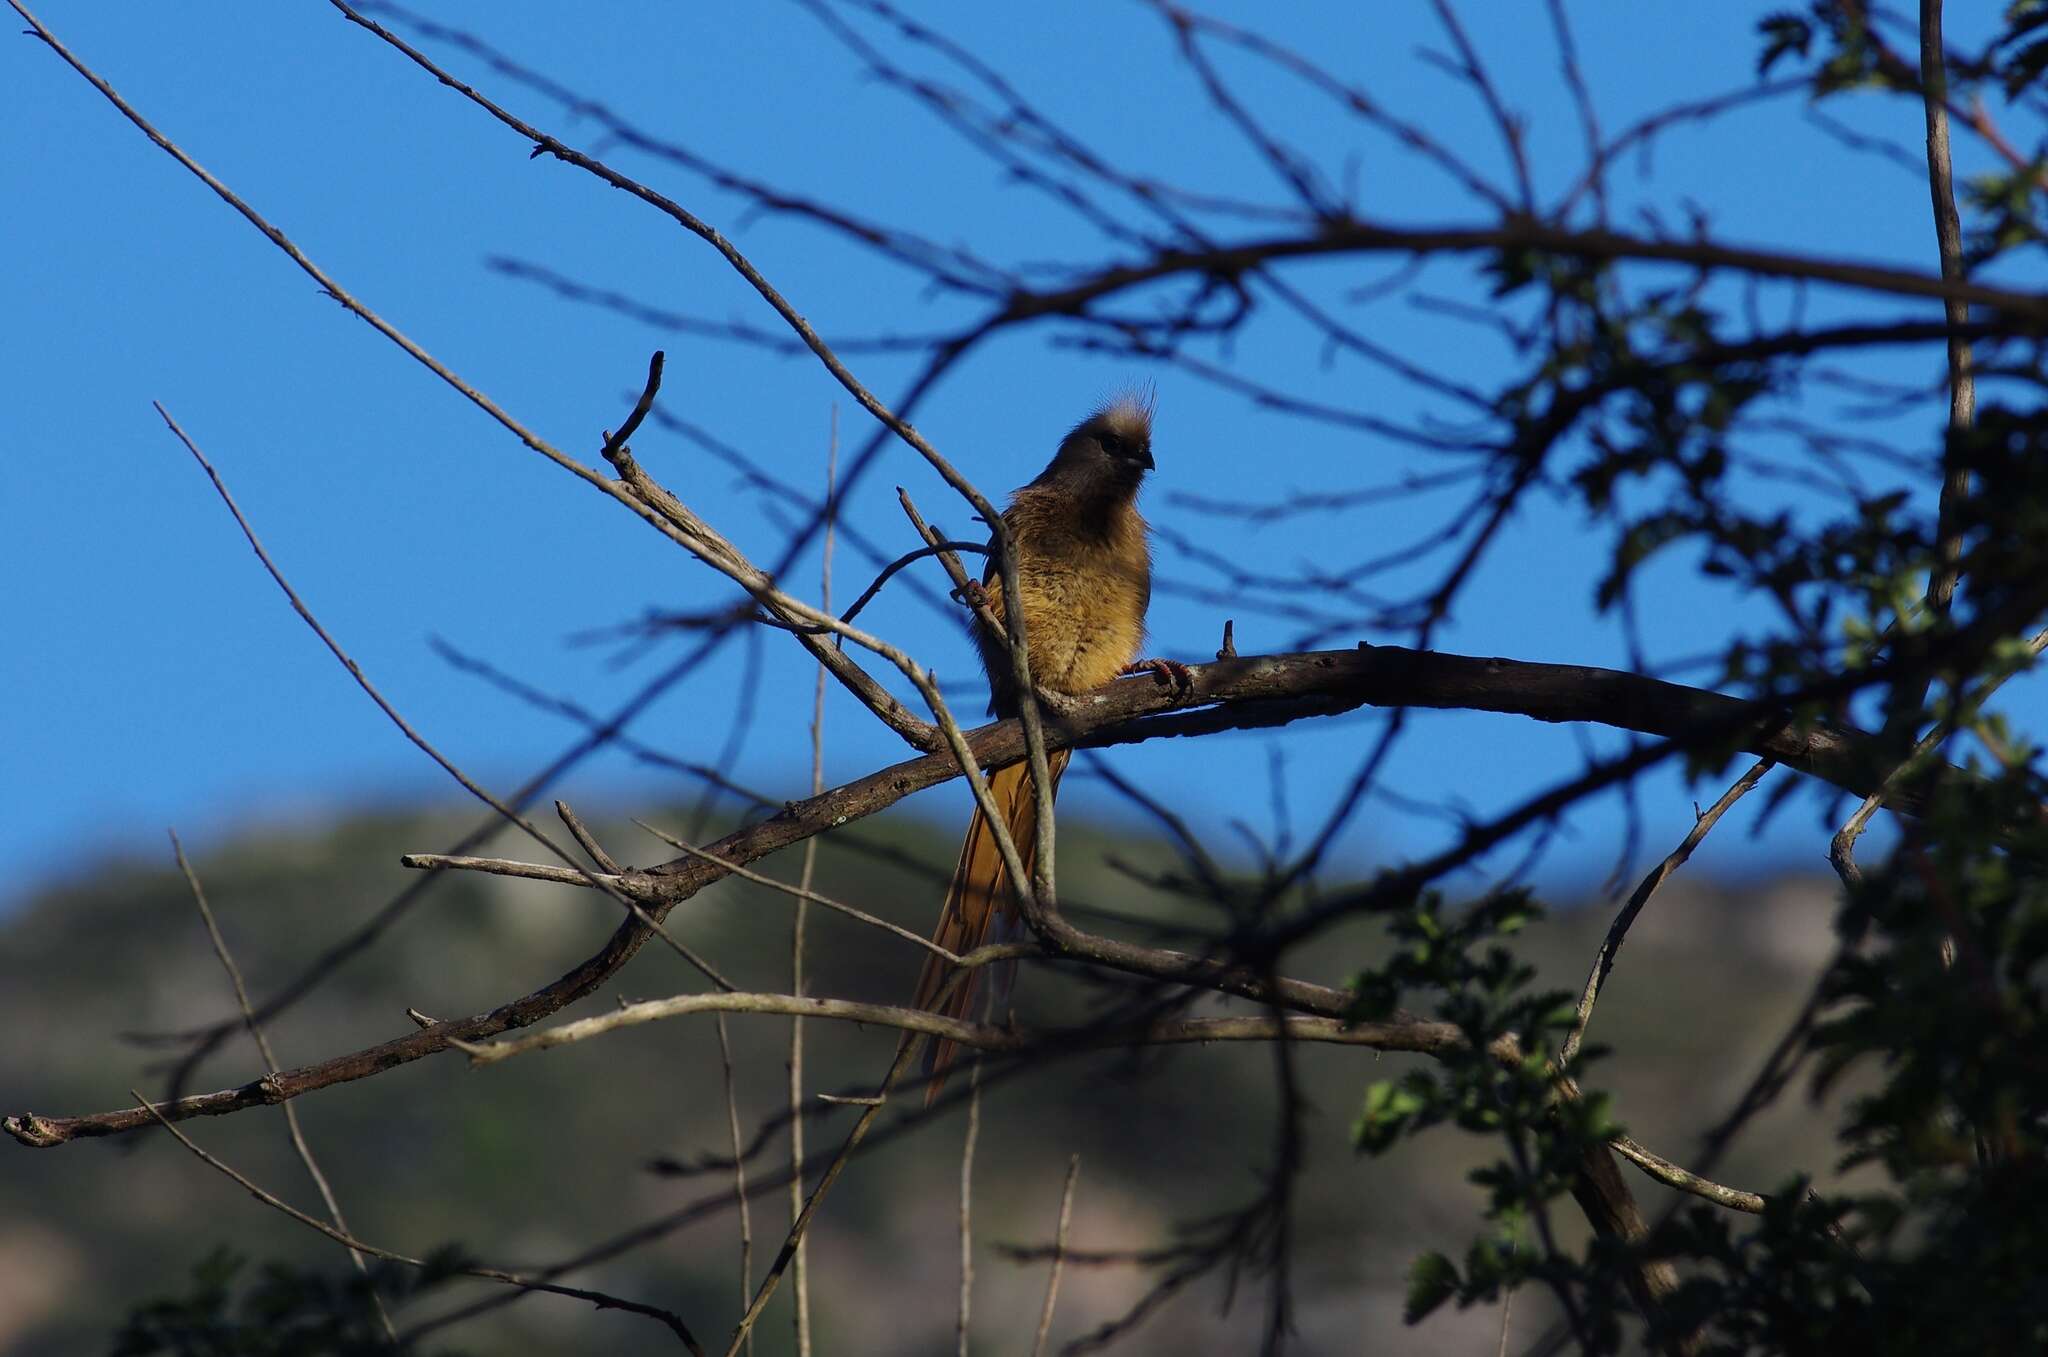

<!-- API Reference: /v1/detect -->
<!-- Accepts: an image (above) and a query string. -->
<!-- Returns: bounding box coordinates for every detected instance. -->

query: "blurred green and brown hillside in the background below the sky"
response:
[0,815,1859,1355]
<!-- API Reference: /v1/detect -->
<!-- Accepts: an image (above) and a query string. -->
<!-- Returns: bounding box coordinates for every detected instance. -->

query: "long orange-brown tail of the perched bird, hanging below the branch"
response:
[913,749,1073,1107]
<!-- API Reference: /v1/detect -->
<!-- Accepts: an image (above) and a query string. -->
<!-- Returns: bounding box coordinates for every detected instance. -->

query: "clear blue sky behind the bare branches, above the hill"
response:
[0,0,2048,912]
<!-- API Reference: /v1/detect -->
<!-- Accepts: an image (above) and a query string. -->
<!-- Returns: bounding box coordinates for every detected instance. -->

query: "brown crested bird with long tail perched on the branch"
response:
[915,397,1184,1105]
